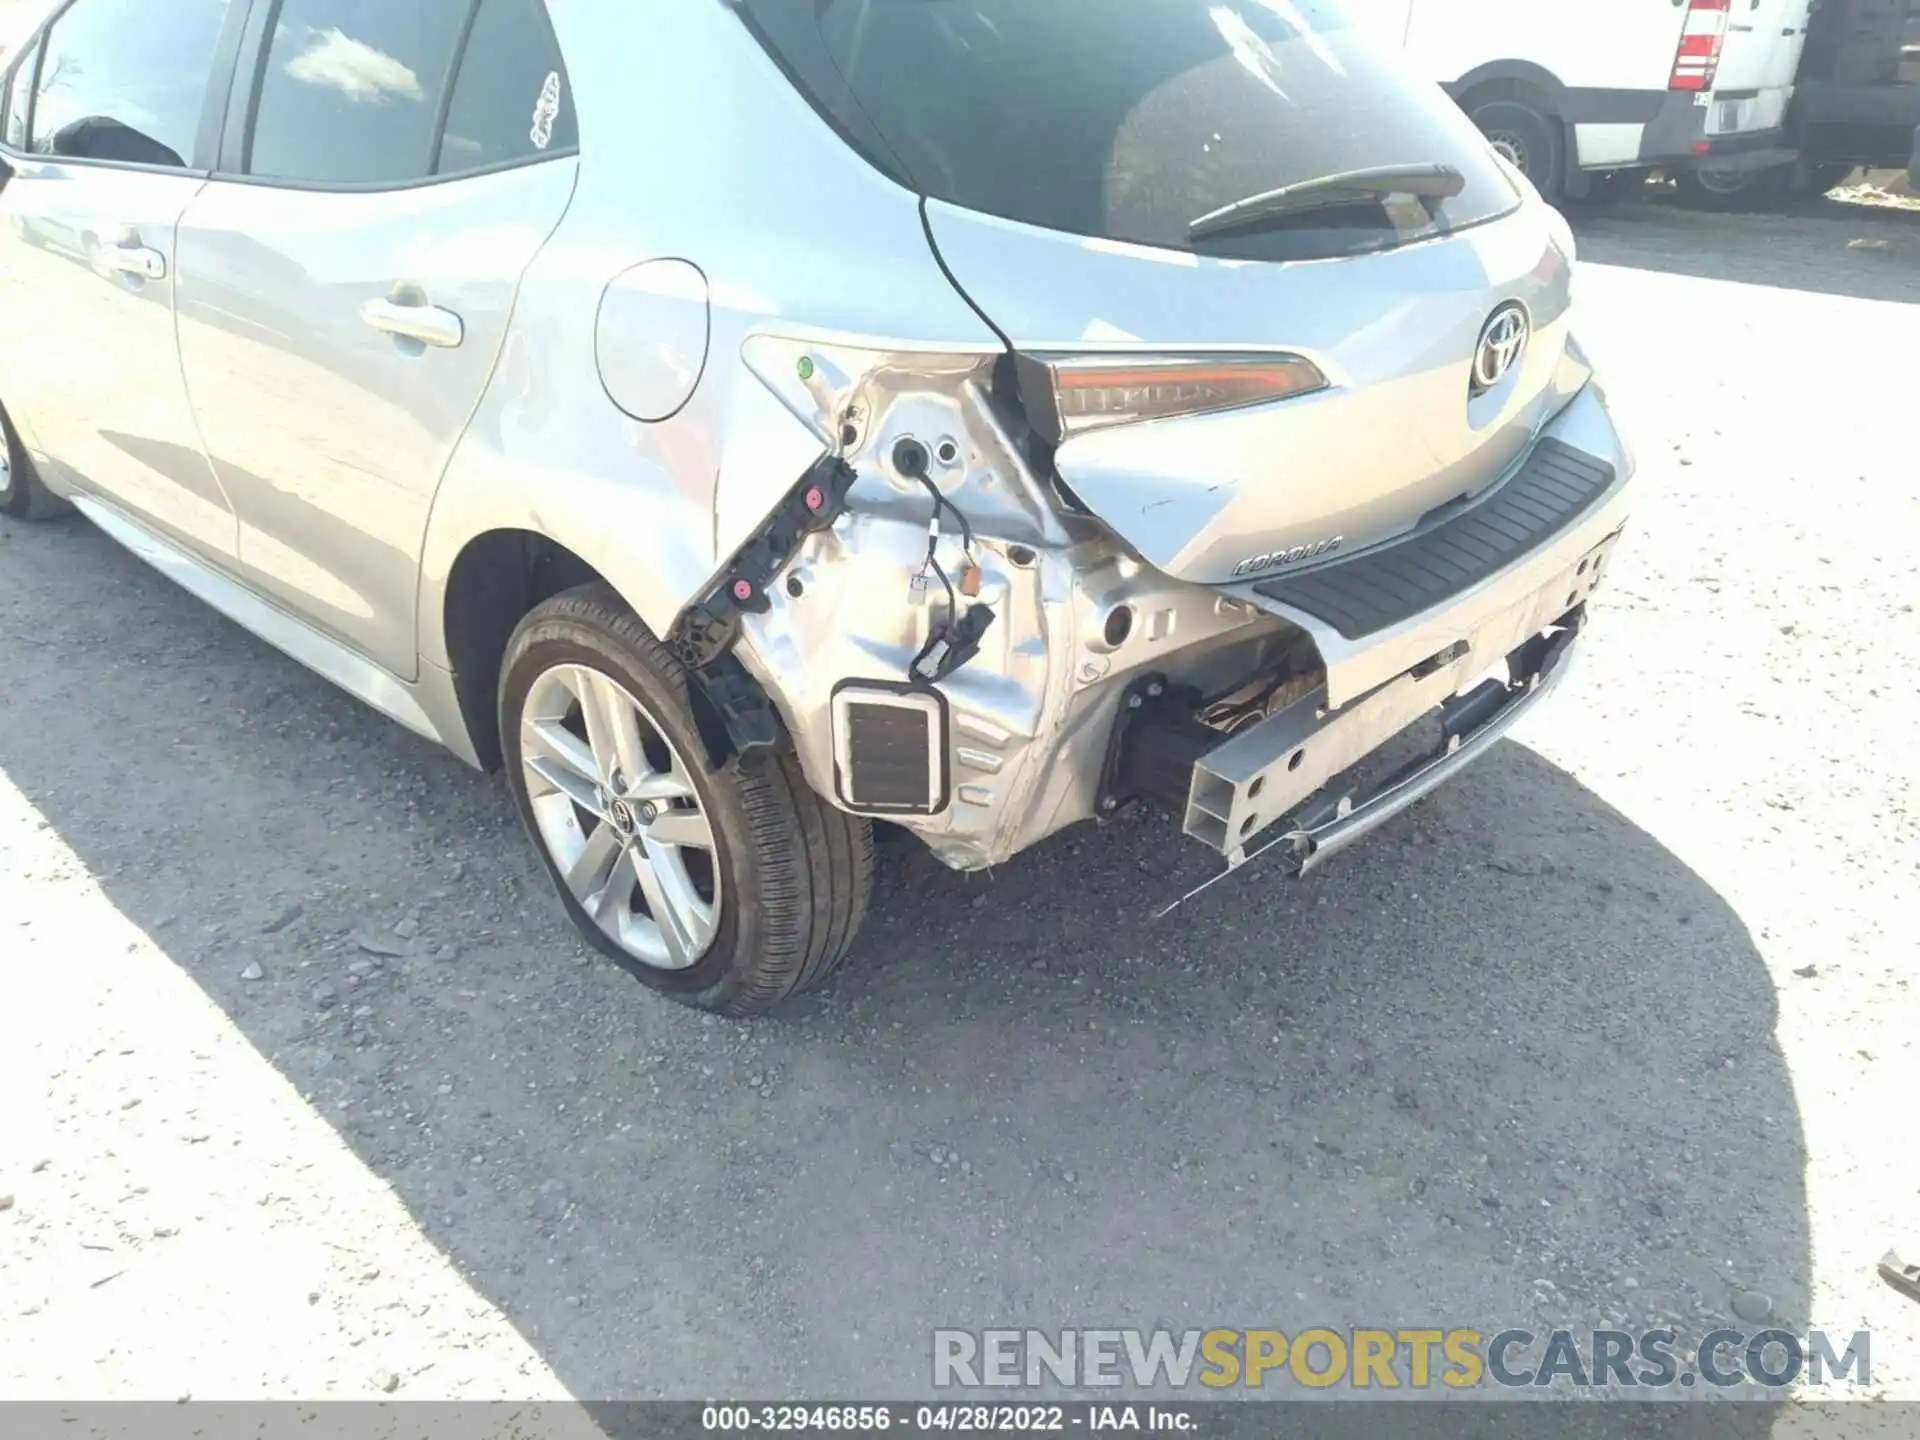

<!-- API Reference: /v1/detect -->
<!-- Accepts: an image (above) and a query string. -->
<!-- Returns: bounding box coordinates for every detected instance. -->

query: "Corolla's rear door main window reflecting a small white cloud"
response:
[249,0,470,184]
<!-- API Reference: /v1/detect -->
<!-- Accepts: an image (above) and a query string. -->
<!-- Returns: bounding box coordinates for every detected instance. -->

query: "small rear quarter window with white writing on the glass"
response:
[440,0,580,175]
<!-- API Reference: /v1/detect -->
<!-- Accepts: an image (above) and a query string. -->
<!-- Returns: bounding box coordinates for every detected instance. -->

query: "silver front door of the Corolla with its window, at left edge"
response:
[0,0,244,561]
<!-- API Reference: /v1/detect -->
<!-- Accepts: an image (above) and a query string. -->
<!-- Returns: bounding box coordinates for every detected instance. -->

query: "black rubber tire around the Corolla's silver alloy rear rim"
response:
[499,584,874,1016]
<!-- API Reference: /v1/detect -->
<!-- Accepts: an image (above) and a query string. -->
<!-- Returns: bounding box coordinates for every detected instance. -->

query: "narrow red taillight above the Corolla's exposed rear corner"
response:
[1021,355,1327,440]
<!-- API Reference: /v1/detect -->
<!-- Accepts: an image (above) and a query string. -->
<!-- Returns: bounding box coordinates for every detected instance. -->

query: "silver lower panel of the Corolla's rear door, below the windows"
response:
[179,159,578,678]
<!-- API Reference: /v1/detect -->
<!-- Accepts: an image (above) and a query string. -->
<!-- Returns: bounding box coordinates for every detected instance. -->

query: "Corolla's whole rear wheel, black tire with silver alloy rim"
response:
[499,586,874,1016]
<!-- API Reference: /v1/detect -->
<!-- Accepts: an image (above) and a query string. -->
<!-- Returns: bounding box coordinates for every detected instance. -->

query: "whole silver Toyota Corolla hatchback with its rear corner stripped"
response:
[0,0,1632,1014]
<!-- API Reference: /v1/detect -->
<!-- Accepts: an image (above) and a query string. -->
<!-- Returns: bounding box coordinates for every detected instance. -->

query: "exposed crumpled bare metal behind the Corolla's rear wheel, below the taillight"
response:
[714,336,1302,870]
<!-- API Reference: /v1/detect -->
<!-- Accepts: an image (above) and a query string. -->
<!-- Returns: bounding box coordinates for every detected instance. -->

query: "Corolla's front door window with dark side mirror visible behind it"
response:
[27,0,228,169]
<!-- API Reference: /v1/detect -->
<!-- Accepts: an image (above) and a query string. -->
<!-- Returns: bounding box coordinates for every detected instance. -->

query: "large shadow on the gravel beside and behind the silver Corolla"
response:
[0,522,1809,1434]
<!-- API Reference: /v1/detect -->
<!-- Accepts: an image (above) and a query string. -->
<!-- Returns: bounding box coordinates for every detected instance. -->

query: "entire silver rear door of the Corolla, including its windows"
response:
[180,0,578,680]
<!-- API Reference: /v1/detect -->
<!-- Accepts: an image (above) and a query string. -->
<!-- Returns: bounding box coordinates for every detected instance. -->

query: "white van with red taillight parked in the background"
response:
[1352,0,1814,200]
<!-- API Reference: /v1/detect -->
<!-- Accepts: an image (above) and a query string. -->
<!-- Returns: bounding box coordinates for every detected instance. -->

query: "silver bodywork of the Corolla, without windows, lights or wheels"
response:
[0,0,1632,868]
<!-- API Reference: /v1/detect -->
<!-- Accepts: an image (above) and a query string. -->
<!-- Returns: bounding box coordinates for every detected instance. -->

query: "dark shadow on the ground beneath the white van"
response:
[1569,190,1920,305]
